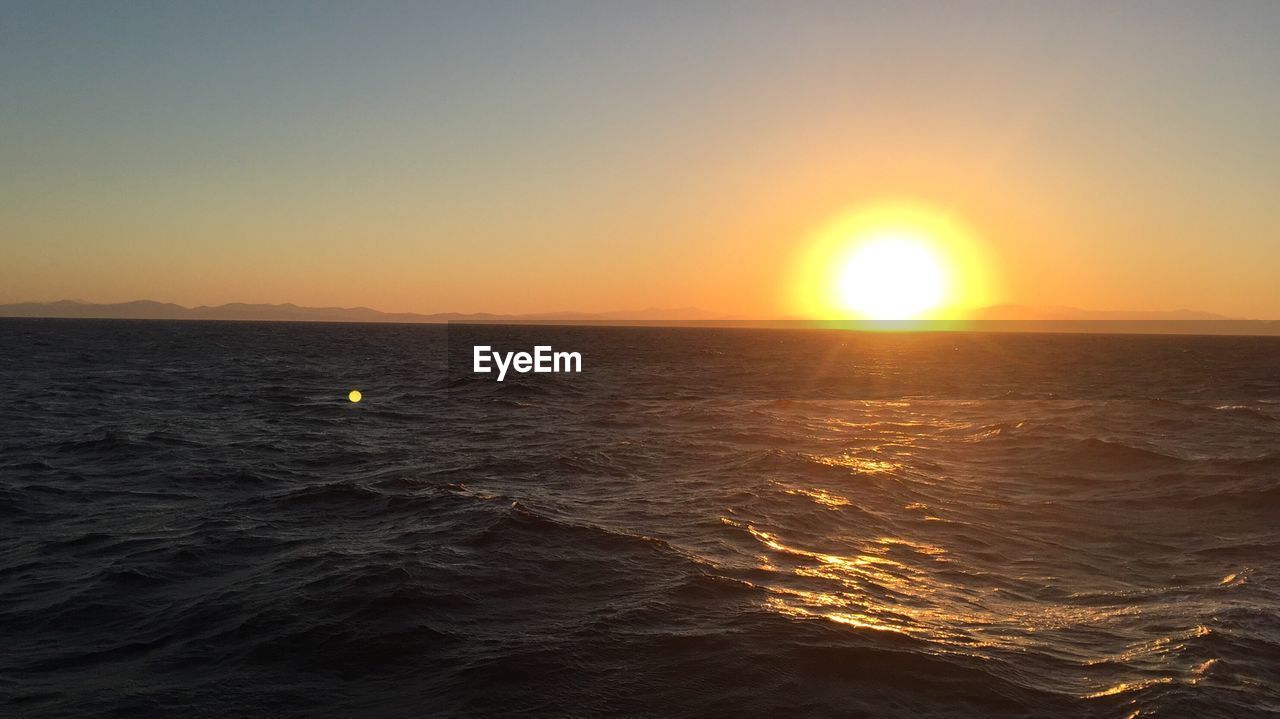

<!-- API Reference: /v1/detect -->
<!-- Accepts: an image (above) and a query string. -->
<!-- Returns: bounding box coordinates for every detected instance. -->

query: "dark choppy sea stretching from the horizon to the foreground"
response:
[0,320,1280,718]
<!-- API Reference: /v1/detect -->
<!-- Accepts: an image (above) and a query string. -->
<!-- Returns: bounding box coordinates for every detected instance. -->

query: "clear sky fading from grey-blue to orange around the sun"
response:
[0,0,1280,319]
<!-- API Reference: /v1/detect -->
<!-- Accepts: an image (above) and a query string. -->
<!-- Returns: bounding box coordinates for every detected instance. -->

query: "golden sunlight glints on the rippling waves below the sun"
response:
[721,404,1248,700]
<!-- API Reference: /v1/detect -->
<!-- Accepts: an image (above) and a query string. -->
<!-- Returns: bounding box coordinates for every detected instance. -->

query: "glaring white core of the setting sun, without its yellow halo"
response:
[836,232,947,320]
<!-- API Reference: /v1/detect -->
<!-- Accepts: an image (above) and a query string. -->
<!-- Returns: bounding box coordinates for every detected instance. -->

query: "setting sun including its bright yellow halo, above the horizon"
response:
[790,201,991,320]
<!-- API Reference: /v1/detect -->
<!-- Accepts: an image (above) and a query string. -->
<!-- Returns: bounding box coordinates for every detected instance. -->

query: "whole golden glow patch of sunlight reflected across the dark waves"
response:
[721,402,1252,707]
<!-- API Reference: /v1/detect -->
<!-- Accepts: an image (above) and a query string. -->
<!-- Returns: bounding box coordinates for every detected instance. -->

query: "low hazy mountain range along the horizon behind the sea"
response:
[0,299,1280,334]
